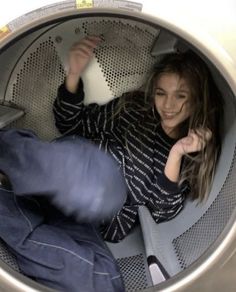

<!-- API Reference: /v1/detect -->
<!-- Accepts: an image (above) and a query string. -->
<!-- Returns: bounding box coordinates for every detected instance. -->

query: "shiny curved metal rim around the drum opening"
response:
[0,1,236,292]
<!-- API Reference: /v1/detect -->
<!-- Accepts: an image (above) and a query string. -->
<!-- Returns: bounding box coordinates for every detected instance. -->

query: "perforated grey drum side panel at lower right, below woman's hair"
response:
[173,144,236,269]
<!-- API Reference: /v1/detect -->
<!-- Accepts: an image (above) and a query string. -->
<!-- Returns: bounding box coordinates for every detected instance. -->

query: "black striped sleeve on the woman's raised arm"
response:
[53,80,118,138]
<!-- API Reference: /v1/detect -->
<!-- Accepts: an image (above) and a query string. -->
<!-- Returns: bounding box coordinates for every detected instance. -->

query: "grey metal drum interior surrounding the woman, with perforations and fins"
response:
[0,8,236,291]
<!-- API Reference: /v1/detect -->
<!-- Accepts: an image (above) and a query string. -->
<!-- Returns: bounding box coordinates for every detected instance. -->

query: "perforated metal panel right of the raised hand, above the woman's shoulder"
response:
[82,18,159,96]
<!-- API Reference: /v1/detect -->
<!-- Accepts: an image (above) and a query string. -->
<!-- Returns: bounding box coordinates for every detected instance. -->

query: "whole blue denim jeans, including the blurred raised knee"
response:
[0,129,126,292]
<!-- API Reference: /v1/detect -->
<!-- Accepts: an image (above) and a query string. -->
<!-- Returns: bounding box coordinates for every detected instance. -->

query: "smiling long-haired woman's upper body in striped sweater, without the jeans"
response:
[54,36,222,242]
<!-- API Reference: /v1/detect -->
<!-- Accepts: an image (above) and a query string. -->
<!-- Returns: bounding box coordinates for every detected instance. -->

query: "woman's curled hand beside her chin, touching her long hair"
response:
[172,128,212,156]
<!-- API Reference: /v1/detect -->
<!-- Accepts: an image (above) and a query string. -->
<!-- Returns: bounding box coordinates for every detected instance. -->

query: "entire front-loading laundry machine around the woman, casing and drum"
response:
[0,0,236,292]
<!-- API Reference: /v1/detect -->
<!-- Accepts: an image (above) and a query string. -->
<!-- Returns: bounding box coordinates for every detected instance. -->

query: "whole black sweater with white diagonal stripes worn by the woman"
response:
[53,81,188,242]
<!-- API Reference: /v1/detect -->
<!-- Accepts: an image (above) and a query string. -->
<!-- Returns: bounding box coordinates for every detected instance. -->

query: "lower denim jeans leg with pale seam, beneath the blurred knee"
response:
[0,188,124,292]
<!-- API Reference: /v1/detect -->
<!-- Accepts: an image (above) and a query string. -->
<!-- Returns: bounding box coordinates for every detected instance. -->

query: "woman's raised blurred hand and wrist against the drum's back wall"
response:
[66,36,101,93]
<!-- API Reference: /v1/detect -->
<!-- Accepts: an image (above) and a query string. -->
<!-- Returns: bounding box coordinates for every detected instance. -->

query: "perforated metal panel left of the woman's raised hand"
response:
[8,37,65,139]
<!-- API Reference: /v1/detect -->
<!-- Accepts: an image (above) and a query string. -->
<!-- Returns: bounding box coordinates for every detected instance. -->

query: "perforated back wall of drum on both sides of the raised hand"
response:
[5,17,159,140]
